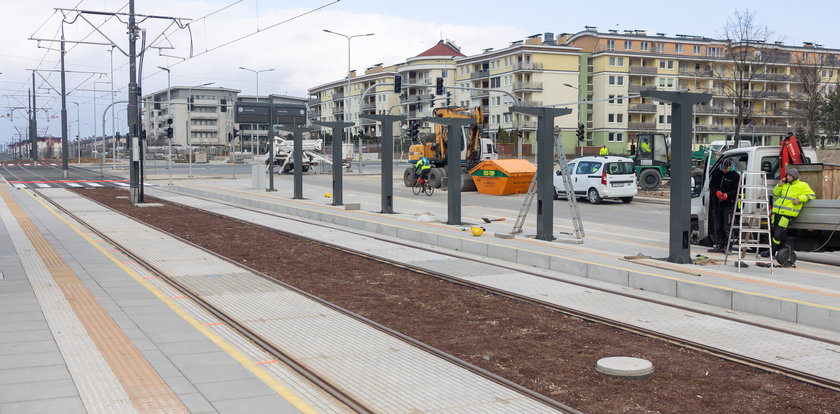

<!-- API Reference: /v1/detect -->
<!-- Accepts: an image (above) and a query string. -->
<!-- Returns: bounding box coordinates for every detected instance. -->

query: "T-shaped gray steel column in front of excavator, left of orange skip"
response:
[423,116,475,225]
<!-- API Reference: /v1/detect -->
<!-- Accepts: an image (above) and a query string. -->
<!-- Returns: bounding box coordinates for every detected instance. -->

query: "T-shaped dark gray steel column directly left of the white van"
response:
[510,106,572,241]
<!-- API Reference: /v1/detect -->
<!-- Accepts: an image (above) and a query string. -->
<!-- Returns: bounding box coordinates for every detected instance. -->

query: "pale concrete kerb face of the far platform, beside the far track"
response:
[162,186,840,331]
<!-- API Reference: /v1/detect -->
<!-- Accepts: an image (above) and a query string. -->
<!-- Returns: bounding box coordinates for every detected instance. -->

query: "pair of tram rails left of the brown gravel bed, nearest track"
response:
[31,189,582,414]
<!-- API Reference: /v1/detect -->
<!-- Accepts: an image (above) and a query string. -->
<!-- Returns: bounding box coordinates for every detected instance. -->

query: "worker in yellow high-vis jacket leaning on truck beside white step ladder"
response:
[771,167,817,256]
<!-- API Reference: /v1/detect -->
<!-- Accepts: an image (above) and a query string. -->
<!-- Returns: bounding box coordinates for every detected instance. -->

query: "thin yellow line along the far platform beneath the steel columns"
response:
[189,184,840,311]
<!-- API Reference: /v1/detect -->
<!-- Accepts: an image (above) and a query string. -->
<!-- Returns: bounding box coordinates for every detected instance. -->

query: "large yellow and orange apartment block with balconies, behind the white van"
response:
[566,27,840,149]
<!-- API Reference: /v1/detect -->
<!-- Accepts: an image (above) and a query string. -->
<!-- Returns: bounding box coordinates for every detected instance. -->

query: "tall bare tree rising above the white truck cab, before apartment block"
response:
[711,10,779,142]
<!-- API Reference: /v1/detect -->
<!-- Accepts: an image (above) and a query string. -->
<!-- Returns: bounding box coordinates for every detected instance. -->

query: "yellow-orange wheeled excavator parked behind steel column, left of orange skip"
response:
[403,107,499,191]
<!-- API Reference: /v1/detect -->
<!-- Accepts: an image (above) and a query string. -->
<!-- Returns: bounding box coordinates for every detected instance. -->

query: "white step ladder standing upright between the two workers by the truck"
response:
[723,171,773,273]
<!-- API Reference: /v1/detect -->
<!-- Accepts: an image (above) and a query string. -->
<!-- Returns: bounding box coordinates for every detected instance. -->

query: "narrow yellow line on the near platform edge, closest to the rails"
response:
[23,193,318,414]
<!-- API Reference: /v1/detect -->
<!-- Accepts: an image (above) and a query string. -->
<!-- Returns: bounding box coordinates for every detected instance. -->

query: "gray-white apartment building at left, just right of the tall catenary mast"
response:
[142,86,240,147]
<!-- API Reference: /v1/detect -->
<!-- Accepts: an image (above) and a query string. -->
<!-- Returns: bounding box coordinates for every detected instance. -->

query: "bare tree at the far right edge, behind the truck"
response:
[791,50,838,148]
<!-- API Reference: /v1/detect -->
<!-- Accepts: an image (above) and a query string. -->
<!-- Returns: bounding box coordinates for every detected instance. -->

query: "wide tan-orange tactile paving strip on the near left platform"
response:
[0,186,189,413]
